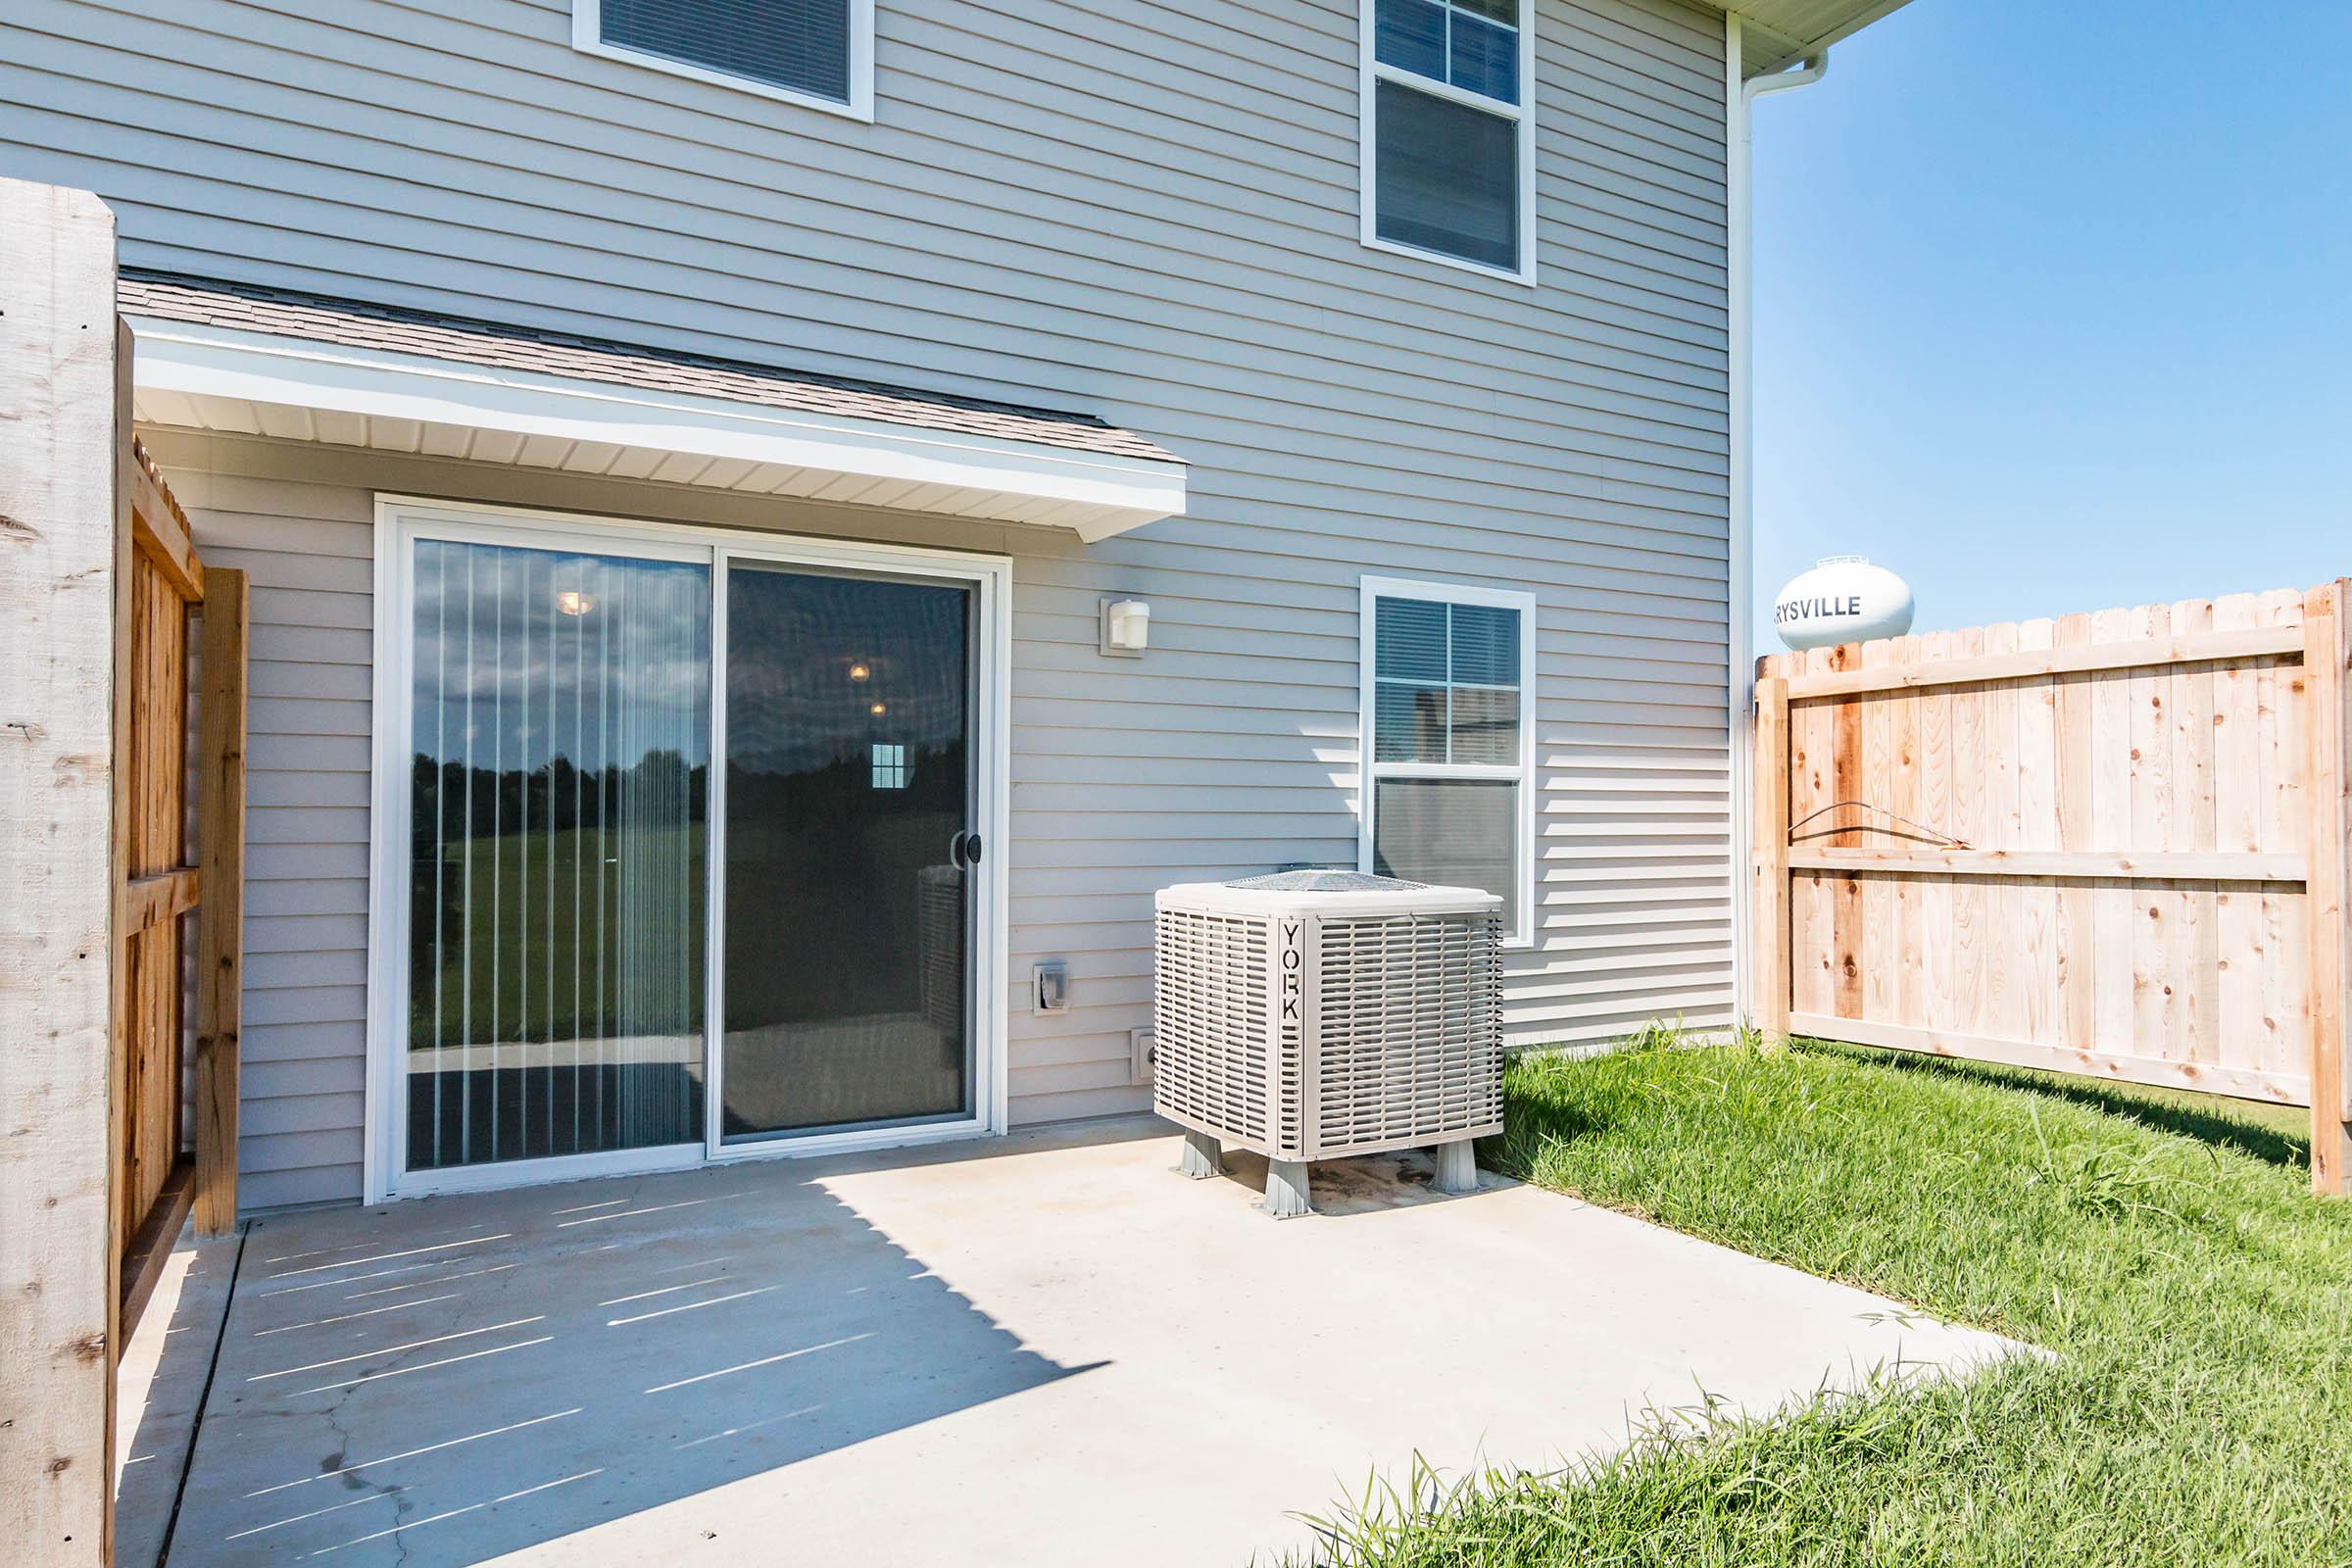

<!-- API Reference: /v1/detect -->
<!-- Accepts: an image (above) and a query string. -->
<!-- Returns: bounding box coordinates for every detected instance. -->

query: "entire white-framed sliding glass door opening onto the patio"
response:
[383,503,1002,1195]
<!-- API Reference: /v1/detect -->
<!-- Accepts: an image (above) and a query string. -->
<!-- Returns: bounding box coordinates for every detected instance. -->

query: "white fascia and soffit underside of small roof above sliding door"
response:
[127,315,1186,541]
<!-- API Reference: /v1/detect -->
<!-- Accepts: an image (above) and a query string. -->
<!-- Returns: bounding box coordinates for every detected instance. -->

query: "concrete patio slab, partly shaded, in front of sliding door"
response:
[156,1121,2011,1568]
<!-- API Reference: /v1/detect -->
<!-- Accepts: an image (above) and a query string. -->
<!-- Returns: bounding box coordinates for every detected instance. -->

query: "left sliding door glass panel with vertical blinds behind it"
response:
[407,538,710,1171]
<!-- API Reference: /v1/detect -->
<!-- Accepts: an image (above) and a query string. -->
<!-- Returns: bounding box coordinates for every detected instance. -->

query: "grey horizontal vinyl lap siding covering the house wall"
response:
[0,0,1731,1201]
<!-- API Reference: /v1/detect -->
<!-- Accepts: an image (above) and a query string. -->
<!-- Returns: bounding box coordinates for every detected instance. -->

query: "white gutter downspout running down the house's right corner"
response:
[1724,12,1830,1022]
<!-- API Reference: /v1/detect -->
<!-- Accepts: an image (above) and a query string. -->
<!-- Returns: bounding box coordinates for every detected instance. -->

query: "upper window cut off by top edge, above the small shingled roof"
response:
[571,0,875,120]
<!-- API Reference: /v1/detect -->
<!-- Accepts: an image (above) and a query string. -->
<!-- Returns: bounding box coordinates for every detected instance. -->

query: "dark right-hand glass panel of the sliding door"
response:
[719,562,968,1140]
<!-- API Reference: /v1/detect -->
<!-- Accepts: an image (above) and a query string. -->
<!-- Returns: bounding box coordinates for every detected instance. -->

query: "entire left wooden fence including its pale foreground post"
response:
[0,178,247,1568]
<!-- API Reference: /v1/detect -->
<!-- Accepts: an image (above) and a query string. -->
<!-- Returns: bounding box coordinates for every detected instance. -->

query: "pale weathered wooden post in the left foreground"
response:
[0,178,129,1568]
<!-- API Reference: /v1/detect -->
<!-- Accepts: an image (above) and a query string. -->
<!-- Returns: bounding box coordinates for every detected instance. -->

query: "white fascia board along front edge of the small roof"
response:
[129,315,1186,541]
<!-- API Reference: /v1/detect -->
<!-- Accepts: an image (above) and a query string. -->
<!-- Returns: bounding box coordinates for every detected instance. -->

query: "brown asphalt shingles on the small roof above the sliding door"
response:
[116,268,1178,464]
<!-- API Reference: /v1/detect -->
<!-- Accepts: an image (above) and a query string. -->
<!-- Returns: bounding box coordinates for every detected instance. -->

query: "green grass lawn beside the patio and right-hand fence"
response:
[1324,1046,2352,1568]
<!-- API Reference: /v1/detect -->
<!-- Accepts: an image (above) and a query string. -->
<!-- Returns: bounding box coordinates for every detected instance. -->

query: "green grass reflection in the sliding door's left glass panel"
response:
[410,823,706,1051]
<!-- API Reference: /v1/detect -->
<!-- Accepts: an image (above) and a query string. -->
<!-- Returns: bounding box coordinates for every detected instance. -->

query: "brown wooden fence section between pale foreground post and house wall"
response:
[113,422,247,1336]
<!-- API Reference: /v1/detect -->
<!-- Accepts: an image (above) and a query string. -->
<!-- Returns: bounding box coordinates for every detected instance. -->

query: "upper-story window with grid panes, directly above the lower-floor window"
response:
[1362,0,1536,282]
